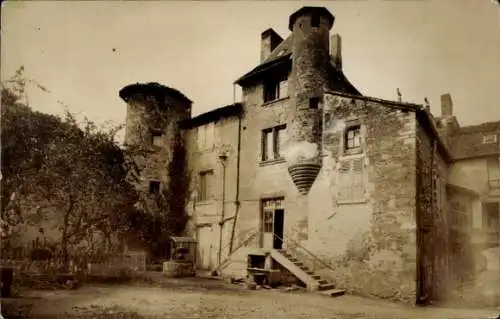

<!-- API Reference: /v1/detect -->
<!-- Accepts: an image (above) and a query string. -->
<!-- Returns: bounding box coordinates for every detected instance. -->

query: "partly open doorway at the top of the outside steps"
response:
[261,198,285,249]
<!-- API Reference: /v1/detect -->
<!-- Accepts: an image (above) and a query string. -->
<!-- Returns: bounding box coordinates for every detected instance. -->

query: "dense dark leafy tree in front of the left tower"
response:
[1,67,137,262]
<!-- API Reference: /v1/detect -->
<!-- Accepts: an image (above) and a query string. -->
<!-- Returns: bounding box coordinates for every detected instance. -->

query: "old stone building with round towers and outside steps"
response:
[120,7,500,303]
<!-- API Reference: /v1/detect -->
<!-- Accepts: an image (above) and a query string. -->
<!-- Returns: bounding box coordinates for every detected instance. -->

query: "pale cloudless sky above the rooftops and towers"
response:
[1,0,500,142]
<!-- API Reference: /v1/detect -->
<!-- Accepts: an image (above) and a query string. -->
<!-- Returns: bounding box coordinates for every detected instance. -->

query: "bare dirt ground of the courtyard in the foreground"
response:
[2,278,500,319]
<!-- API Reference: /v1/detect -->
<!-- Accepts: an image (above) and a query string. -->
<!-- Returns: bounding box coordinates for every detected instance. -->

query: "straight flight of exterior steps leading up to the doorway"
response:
[271,249,345,297]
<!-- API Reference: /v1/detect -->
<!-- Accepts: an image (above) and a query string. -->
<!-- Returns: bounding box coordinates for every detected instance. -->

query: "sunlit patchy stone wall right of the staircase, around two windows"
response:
[307,94,417,302]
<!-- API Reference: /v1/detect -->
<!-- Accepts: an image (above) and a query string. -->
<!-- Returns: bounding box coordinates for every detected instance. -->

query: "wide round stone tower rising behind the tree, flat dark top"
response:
[119,83,192,193]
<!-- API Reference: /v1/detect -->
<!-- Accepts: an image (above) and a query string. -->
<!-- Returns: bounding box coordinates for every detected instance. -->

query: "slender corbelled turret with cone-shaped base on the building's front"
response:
[287,7,335,195]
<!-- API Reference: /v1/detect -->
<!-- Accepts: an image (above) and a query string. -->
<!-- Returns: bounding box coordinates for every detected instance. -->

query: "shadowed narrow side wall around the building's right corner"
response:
[416,121,449,303]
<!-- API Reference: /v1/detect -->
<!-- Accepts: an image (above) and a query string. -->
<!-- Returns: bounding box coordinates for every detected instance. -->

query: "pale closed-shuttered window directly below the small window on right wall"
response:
[338,157,365,201]
